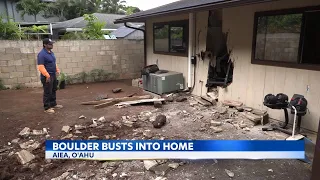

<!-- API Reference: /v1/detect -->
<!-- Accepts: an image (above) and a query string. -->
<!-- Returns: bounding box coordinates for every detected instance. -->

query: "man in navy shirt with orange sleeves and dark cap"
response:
[38,38,62,114]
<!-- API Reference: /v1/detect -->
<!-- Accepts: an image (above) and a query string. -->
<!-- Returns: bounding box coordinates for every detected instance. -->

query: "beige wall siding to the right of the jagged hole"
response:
[219,0,320,131]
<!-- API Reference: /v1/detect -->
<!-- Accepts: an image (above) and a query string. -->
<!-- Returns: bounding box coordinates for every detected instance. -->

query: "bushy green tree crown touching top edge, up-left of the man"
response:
[16,0,46,21]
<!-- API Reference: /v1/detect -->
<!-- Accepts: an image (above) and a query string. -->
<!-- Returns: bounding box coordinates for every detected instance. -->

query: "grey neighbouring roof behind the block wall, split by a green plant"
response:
[52,13,125,29]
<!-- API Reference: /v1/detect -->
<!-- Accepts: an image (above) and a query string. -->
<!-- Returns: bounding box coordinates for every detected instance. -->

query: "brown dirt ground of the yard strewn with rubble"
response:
[0,81,311,180]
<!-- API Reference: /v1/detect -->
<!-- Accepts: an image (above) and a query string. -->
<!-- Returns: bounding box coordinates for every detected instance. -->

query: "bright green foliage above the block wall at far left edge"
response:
[0,15,25,40]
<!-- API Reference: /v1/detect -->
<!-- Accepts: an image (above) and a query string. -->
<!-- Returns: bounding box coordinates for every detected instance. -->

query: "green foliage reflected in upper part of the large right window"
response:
[258,14,302,34]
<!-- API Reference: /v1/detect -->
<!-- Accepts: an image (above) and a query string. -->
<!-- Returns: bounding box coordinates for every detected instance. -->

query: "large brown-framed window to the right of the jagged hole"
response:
[252,7,320,70]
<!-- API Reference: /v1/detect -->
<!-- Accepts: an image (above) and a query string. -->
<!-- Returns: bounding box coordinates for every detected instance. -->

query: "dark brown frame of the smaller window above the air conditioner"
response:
[152,19,189,57]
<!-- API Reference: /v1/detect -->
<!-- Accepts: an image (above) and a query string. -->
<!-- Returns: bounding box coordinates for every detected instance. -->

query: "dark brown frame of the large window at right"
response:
[251,6,320,71]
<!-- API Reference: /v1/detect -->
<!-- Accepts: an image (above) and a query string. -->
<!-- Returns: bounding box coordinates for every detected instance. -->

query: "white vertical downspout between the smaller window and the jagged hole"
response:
[188,13,195,89]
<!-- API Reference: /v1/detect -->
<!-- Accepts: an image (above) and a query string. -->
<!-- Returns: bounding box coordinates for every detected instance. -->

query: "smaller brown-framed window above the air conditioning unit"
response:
[153,21,188,56]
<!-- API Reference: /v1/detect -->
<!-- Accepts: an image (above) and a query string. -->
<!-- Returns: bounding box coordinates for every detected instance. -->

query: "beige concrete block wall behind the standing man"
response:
[0,40,144,88]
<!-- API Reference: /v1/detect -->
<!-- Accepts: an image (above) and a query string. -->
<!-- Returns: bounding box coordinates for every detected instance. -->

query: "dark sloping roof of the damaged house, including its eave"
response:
[115,0,277,23]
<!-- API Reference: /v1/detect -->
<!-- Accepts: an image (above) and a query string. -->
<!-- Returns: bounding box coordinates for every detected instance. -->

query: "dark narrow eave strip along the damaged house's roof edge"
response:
[114,0,279,24]
